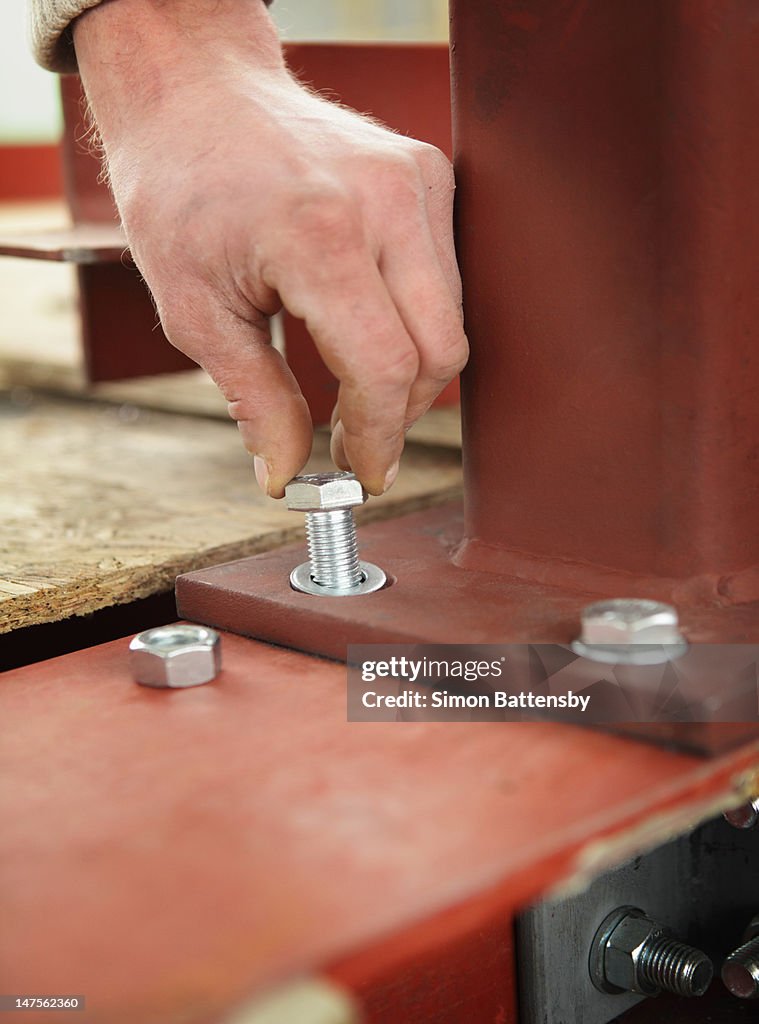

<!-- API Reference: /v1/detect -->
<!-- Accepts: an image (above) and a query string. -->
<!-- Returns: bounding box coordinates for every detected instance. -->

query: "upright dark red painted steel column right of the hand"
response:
[452,0,759,601]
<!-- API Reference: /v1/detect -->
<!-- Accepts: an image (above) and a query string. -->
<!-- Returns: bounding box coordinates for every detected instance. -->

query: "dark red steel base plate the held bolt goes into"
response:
[176,504,759,752]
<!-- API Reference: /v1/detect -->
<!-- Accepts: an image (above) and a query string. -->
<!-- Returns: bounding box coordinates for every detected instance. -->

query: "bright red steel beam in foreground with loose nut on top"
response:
[0,635,759,1024]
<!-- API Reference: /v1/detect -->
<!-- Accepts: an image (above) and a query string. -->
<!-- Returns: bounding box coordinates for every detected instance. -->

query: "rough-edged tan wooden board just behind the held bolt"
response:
[0,391,460,632]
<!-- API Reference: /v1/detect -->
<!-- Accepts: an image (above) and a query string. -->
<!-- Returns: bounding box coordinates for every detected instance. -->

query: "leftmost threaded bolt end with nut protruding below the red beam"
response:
[589,906,714,996]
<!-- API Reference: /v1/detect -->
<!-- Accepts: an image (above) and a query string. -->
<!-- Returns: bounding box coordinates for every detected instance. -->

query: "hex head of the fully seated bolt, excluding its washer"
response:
[582,598,682,645]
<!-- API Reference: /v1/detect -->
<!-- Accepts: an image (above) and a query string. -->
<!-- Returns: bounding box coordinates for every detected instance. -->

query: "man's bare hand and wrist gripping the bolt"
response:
[74,0,467,497]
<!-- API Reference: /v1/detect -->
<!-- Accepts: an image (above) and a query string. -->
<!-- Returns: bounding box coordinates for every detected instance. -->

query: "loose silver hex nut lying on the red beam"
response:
[129,623,221,689]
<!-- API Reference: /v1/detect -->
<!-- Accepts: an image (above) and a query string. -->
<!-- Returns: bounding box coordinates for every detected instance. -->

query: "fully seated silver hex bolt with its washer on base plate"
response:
[572,597,687,665]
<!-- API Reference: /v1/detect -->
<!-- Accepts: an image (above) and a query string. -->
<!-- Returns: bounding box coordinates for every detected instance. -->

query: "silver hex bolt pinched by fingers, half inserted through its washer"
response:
[285,473,387,597]
